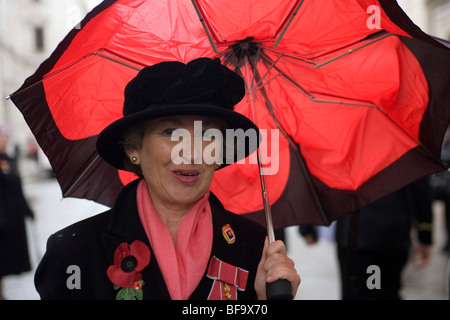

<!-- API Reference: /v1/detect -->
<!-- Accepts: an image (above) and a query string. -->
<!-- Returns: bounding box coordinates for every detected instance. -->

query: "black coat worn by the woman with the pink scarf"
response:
[35,180,266,300]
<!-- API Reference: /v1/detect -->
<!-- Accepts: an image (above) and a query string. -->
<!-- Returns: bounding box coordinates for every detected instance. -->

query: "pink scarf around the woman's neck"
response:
[137,180,213,300]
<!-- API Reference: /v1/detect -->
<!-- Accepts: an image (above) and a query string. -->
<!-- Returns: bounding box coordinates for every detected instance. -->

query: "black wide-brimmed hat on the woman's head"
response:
[97,58,260,170]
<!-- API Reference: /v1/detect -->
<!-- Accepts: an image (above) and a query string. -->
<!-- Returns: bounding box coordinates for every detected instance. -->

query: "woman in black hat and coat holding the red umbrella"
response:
[35,58,300,300]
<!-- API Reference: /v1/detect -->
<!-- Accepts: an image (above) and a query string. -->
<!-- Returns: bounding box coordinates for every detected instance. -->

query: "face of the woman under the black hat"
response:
[126,116,220,206]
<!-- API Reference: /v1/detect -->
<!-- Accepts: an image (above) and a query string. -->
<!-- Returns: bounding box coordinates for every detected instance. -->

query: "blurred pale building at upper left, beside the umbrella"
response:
[0,0,101,159]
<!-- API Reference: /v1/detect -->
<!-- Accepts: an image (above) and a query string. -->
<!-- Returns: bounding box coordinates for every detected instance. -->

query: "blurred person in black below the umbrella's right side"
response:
[336,177,432,300]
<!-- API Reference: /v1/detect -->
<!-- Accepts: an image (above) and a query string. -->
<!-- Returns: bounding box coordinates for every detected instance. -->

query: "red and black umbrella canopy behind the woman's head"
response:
[11,0,450,228]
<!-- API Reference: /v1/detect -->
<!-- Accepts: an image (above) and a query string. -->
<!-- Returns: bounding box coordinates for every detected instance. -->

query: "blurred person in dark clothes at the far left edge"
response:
[0,125,33,300]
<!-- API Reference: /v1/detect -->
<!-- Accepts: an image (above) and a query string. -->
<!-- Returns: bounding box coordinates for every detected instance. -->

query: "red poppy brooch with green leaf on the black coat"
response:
[106,240,150,300]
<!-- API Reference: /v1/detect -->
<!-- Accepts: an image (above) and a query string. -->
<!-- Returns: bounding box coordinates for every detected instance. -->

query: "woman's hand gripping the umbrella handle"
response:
[255,237,301,300]
